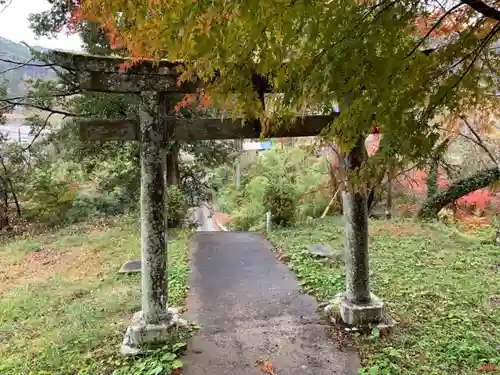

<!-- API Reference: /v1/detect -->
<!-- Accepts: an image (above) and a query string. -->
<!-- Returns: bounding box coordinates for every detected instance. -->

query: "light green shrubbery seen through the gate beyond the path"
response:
[214,148,333,230]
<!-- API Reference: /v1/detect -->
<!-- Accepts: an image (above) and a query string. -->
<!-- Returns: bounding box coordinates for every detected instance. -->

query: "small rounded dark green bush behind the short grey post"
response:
[264,180,296,225]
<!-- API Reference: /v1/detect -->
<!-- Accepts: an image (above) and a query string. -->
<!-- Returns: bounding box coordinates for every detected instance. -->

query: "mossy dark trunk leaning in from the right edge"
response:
[417,167,500,219]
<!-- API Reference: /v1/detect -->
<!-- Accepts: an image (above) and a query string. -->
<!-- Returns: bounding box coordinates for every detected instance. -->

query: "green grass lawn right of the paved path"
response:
[270,218,500,375]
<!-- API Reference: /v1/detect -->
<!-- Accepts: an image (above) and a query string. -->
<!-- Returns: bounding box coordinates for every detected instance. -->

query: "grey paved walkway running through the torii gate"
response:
[183,232,358,375]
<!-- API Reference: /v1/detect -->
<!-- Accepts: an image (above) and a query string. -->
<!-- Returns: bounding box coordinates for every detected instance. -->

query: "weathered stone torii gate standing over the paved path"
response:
[50,51,381,354]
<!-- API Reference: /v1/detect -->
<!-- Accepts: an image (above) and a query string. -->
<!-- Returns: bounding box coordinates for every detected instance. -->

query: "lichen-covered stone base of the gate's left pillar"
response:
[120,308,188,355]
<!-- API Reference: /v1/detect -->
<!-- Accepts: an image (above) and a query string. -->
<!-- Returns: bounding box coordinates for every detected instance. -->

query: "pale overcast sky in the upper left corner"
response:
[0,0,81,50]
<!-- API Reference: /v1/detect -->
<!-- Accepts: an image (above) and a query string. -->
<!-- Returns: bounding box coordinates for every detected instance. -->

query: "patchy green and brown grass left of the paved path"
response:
[0,218,188,375]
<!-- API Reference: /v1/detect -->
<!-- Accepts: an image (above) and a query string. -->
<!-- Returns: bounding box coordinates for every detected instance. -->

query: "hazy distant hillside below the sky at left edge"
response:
[0,37,55,97]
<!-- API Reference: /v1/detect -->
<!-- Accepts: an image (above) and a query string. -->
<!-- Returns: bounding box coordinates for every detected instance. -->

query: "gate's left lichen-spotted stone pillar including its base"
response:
[120,91,187,355]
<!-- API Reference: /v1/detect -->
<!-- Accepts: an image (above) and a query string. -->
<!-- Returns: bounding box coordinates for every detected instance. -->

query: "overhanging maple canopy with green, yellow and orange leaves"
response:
[60,0,500,223]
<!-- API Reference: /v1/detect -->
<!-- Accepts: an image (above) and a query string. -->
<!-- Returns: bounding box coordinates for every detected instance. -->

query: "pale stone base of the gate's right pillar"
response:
[325,293,385,327]
